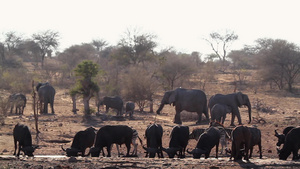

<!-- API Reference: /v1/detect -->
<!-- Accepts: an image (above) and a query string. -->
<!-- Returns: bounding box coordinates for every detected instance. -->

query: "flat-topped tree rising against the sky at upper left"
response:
[32,30,59,68]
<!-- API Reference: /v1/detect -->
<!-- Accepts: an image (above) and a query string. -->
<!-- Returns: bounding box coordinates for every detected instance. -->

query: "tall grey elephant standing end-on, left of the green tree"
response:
[36,82,55,114]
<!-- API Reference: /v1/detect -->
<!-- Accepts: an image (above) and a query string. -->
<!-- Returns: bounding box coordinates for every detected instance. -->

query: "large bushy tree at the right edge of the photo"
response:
[256,39,300,92]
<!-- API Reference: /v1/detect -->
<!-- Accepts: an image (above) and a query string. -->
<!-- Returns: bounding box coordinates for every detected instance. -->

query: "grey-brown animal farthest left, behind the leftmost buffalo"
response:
[8,93,27,115]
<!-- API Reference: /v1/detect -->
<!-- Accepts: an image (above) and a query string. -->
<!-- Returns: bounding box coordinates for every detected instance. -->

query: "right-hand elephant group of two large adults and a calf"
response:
[157,88,251,126]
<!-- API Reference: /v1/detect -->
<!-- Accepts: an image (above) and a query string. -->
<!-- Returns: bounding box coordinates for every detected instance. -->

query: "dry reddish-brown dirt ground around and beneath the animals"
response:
[0,90,300,168]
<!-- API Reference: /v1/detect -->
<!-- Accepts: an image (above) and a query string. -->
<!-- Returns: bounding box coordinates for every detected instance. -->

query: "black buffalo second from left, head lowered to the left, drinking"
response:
[61,127,96,157]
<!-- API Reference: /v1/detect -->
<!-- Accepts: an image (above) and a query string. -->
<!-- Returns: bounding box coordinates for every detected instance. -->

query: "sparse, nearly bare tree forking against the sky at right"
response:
[204,30,238,71]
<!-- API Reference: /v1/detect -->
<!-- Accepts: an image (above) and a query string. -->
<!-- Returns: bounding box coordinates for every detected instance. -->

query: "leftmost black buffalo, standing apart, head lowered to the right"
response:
[13,123,37,156]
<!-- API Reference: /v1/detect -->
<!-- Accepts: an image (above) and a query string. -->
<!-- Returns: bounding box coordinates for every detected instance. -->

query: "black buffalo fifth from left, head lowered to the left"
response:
[163,126,190,158]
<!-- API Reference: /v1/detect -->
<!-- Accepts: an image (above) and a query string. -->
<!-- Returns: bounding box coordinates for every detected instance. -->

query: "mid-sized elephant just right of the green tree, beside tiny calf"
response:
[98,96,123,116]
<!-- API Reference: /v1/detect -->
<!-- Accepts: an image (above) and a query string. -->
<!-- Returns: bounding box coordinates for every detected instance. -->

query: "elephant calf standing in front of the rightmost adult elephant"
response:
[210,104,232,124]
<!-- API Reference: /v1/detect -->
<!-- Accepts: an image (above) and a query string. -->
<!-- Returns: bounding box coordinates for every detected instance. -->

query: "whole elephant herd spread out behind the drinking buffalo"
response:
[9,82,251,126]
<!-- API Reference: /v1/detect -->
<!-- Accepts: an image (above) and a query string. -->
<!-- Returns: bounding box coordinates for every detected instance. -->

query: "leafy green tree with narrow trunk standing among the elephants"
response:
[70,60,99,115]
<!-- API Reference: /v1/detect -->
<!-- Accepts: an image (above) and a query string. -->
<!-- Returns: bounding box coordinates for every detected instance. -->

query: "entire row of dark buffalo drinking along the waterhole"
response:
[13,122,300,161]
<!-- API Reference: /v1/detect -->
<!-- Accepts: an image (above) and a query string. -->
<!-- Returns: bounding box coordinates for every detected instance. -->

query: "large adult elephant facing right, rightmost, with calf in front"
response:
[208,92,251,126]
